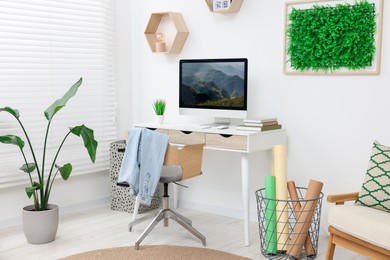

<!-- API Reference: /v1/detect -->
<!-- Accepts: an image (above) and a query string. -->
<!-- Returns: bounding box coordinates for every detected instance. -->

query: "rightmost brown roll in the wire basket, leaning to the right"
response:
[287,180,324,259]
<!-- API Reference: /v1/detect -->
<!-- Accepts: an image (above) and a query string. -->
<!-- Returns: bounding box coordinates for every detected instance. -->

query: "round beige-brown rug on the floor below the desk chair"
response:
[62,245,249,260]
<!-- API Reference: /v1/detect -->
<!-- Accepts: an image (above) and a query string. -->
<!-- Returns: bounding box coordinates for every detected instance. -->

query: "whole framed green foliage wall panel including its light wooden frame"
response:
[283,0,383,75]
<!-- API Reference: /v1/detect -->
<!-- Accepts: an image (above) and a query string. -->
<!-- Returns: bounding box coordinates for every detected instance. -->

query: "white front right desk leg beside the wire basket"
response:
[241,153,249,246]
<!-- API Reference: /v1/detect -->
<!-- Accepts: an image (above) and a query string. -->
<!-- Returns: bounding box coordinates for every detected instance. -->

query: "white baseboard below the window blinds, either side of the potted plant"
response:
[0,197,111,230]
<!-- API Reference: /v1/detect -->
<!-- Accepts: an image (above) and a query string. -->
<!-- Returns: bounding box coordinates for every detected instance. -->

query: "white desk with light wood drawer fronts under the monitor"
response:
[135,123,286,246]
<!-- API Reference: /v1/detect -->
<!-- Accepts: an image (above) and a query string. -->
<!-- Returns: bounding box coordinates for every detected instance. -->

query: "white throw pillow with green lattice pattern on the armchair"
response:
[356,141,390,212]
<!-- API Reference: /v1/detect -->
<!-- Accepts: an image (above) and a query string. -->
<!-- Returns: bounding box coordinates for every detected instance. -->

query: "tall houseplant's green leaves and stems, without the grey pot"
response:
[0,78,98,211]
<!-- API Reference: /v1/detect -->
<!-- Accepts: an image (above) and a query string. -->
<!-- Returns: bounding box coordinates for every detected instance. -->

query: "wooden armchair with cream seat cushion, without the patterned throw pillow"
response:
[326,192,390,260]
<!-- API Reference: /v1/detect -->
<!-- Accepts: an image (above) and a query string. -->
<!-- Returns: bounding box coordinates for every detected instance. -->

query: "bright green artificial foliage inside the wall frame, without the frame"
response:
[287,1,376,71]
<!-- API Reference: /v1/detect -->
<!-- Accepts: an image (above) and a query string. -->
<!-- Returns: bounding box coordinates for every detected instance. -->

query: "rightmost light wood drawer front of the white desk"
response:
[206,134,247,150]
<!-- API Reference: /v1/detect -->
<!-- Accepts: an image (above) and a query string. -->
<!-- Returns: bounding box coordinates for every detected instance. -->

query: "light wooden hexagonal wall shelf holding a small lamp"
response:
[145,12,189,53]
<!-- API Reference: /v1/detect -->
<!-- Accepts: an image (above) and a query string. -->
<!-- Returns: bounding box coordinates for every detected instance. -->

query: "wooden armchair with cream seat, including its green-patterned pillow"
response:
[326,141,390,260]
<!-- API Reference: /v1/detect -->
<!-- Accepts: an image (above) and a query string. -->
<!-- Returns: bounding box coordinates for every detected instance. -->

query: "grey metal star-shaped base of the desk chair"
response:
[129,197,206,250]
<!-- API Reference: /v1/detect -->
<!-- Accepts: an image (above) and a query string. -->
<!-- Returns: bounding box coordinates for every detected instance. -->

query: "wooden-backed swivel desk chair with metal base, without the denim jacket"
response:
[129,144,206,250]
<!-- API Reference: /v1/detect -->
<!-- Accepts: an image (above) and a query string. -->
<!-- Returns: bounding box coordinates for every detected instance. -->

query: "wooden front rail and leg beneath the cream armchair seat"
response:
[326,226,390,260]
